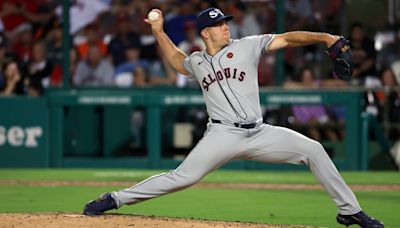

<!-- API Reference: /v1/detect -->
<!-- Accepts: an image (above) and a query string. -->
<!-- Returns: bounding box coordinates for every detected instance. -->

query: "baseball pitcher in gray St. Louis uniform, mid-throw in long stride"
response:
[83,8,384,228]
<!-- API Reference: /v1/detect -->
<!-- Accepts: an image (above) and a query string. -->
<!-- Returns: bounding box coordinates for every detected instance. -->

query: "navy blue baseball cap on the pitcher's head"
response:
[196,7,233,34]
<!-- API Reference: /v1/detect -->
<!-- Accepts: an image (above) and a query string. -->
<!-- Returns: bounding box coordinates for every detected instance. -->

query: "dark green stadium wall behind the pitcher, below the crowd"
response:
[0,88,368,170]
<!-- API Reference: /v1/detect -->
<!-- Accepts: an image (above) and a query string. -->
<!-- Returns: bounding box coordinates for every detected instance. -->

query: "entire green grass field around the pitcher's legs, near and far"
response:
[0,169,400,227]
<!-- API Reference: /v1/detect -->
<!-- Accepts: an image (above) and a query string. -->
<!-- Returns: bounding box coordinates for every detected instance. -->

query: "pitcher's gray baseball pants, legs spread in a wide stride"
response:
[112,123,361,215]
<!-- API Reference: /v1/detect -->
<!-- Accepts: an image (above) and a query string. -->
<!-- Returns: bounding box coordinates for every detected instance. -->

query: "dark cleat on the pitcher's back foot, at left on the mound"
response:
[83,193,117,215]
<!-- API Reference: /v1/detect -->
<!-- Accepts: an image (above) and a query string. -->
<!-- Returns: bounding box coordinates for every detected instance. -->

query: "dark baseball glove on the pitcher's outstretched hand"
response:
[325,36,353,81]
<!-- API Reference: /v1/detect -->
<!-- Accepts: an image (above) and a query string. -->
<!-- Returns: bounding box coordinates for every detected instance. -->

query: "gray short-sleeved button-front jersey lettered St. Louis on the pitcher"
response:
[184,34,274,123]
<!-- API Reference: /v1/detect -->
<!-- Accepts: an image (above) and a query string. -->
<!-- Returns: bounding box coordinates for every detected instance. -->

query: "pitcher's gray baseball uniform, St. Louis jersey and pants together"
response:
[112,35,361,215]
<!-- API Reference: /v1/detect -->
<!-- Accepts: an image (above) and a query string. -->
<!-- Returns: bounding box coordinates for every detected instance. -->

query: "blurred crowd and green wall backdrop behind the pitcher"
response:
[0,0,400,171]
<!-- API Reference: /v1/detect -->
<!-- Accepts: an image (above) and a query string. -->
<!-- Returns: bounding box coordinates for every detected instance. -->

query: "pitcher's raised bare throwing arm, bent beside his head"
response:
[145,9,189,75]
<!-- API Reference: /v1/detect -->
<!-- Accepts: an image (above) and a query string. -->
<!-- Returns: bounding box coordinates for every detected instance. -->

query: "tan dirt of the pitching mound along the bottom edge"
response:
[0,213,310,228]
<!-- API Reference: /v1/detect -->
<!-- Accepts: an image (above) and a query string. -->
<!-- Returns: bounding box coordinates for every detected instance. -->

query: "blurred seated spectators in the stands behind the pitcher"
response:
[0,0,400,142]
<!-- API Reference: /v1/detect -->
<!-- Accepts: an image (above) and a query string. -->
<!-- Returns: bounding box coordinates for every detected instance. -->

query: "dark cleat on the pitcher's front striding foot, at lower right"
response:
[336,211,384,228]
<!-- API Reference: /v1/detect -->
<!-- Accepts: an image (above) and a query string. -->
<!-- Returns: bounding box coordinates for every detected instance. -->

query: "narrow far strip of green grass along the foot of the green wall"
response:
[0,169,400,185]
